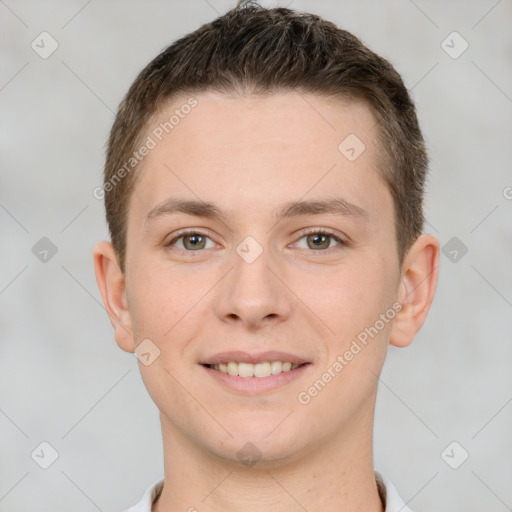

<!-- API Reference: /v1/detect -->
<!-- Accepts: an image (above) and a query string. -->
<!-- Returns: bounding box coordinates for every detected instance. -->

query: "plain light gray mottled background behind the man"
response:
[0,0,512,512]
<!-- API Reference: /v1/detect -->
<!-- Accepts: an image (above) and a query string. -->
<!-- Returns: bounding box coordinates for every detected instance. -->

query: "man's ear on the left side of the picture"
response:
[93,241,135,352]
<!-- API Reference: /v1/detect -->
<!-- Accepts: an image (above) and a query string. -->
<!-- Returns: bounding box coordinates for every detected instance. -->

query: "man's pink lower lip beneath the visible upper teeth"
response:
[203,363,311,394]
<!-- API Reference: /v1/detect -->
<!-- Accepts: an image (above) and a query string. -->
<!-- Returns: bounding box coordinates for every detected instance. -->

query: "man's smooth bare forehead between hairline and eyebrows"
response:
[130,92,389,225]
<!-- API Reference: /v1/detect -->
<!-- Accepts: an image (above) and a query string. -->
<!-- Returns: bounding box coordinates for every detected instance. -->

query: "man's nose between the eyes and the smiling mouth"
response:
[214,244,293,331]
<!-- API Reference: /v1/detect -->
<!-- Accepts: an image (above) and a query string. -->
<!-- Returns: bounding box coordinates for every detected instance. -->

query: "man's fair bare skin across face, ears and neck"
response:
[94,92,439,512]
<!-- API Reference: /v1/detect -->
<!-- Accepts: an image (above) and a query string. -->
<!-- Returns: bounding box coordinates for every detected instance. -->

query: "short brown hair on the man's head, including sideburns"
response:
[104,2,428,272]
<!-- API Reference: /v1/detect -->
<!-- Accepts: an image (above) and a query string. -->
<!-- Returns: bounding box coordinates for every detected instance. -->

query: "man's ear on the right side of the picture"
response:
[390,235,439,347]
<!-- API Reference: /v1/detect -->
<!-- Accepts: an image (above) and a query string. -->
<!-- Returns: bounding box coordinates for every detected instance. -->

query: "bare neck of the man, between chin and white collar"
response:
[153,415,384,512]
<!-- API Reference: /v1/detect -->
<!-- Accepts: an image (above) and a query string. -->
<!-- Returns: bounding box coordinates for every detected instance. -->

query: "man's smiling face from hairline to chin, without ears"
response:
[120,93,400,461]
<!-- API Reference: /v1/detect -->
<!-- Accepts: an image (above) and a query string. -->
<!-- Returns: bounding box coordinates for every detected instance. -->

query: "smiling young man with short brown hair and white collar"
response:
[94,5,439,512]
